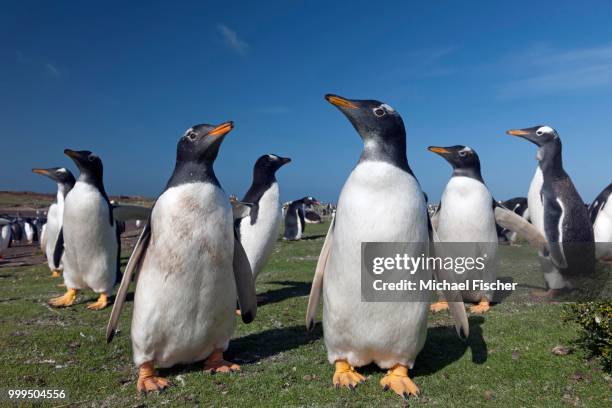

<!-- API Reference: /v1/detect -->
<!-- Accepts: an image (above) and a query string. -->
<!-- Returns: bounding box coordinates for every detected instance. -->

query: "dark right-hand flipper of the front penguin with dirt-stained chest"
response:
[233,237,257,323]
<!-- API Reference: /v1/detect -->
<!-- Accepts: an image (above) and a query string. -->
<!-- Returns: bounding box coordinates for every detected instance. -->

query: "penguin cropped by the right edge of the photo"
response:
[589,183,612,262]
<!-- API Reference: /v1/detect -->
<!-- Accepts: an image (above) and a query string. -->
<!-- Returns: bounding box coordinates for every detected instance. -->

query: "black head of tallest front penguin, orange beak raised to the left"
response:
[325,94,412,174]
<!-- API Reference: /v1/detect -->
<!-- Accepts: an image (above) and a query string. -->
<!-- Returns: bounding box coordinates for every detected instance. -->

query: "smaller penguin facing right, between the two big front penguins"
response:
[234,154,291,279]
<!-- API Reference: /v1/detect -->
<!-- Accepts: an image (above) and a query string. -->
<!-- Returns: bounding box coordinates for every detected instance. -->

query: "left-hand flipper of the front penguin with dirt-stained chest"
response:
[106,220,151,343]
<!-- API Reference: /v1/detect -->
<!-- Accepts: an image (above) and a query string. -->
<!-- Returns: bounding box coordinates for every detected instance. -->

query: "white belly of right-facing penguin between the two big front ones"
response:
[240,183,281,278]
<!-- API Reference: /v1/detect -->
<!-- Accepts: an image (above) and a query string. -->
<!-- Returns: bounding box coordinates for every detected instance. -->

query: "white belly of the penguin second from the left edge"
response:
[62,181,118,293]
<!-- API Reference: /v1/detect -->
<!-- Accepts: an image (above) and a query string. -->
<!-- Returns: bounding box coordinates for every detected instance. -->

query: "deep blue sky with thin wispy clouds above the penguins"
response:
[0,1,612,201]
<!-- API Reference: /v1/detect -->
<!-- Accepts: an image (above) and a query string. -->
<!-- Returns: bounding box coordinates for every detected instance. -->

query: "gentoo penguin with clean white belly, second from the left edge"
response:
[49,149,120,310]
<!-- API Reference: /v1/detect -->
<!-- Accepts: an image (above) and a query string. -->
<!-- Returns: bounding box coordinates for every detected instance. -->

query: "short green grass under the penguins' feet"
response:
[0,224,611,407]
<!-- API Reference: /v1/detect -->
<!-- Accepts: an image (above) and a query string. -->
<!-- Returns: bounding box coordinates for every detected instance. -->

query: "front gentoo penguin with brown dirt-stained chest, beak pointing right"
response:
[106,122,257,391]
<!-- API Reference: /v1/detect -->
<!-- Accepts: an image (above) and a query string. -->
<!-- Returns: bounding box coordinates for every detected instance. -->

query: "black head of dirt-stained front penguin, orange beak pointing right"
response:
[176,122,234,164]
